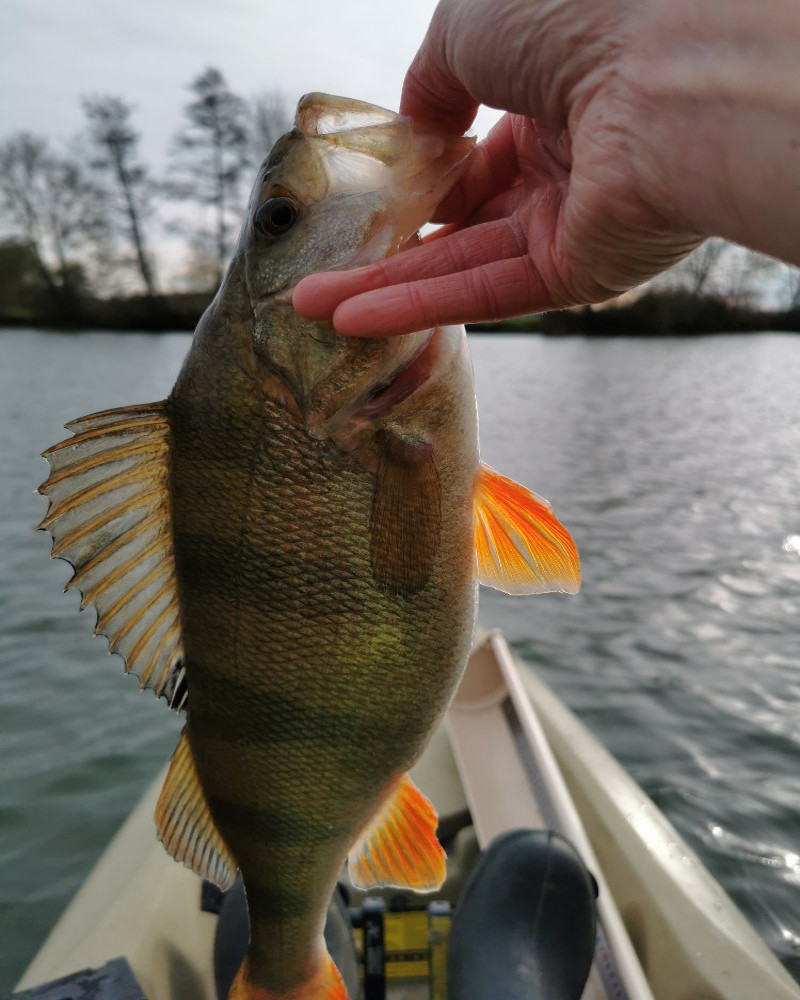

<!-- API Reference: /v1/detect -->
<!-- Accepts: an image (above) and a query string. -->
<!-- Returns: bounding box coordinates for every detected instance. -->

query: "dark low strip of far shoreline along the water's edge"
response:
[0,292,800,337]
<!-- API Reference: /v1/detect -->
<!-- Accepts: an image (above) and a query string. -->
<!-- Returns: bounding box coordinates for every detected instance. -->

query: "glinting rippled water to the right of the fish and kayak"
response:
[473,335,800,979]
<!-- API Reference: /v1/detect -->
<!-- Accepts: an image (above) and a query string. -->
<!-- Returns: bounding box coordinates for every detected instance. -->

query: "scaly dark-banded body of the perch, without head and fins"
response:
[166,388,475,982]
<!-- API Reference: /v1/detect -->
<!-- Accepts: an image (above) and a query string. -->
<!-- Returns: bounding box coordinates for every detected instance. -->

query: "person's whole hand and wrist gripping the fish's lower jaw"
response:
[294,0,800,336]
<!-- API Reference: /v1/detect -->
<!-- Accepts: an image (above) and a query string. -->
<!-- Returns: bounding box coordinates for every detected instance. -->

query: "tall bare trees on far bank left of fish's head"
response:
[0,67,291,317]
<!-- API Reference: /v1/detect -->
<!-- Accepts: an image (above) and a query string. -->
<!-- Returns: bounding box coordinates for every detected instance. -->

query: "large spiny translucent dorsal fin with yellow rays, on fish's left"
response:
[39,403,186,708]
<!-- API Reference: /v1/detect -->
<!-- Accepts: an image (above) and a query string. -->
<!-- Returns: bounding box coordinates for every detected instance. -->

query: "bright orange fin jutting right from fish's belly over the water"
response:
[474,462,581,594]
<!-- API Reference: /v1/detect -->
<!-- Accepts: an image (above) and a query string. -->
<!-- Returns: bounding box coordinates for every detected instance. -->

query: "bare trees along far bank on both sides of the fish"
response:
[0,67,800,326]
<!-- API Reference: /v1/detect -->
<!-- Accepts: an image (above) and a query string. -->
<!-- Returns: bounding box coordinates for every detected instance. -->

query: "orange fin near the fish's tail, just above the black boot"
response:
[348,774,446,892]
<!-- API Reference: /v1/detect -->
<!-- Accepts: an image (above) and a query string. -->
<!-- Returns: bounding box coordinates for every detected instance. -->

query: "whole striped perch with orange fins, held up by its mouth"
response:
[40,94,579,1000]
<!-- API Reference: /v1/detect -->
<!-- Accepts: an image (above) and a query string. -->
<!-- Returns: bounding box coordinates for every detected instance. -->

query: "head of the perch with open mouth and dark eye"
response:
[237,94,474,436]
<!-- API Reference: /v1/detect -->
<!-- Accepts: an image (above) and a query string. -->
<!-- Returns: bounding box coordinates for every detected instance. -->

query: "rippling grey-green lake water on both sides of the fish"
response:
[0,331,800,1000]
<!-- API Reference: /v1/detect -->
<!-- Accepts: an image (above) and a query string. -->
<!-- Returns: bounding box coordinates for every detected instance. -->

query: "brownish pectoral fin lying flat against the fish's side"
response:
[370,431,442,594]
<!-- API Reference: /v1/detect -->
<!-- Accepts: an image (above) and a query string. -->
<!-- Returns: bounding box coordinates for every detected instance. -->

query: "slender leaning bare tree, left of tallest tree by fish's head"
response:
[83,95,156,297]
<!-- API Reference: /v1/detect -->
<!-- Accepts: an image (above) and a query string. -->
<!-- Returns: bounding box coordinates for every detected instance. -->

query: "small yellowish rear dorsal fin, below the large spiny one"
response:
[156,726,236,889]
